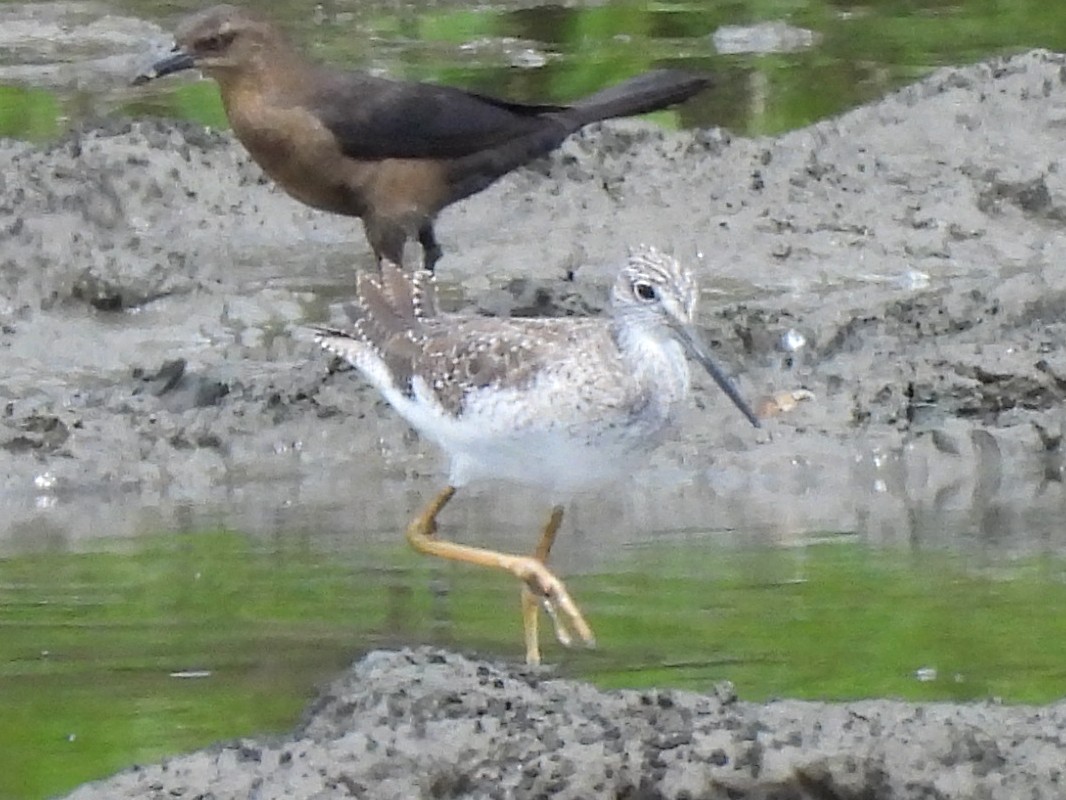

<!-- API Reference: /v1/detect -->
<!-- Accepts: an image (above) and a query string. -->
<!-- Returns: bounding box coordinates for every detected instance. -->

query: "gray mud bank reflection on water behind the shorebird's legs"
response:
[6,416,1066,558]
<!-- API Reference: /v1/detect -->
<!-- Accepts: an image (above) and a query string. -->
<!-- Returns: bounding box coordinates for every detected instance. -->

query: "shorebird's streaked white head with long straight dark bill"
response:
[611,245,759,428]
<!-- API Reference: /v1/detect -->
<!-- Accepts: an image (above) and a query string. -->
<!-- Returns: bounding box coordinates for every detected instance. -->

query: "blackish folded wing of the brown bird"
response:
[310,73,568,160]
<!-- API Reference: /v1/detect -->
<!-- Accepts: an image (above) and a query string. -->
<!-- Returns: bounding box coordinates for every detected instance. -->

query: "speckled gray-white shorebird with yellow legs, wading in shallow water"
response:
[314,247,759,663]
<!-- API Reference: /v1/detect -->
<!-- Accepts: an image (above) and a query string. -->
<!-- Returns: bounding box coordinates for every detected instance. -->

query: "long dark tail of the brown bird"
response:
[560,69,711,127]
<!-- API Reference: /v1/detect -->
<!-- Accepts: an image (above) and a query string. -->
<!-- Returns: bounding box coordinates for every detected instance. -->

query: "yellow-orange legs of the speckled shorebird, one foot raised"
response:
[407,486,596,663]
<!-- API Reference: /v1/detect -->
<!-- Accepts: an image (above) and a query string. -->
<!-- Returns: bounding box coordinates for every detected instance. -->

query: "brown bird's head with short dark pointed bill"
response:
[133,5,288,84]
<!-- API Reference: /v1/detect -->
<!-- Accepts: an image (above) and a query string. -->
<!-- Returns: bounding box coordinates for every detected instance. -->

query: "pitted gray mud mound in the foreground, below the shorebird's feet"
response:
[62,650,1066,800]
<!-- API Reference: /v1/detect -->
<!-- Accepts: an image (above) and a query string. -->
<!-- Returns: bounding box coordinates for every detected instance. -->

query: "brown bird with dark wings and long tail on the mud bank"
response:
[134,5,710,270]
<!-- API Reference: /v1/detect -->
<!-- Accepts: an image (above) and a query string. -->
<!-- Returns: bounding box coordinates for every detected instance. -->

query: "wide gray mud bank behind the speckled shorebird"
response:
[6,51,1066,550]
